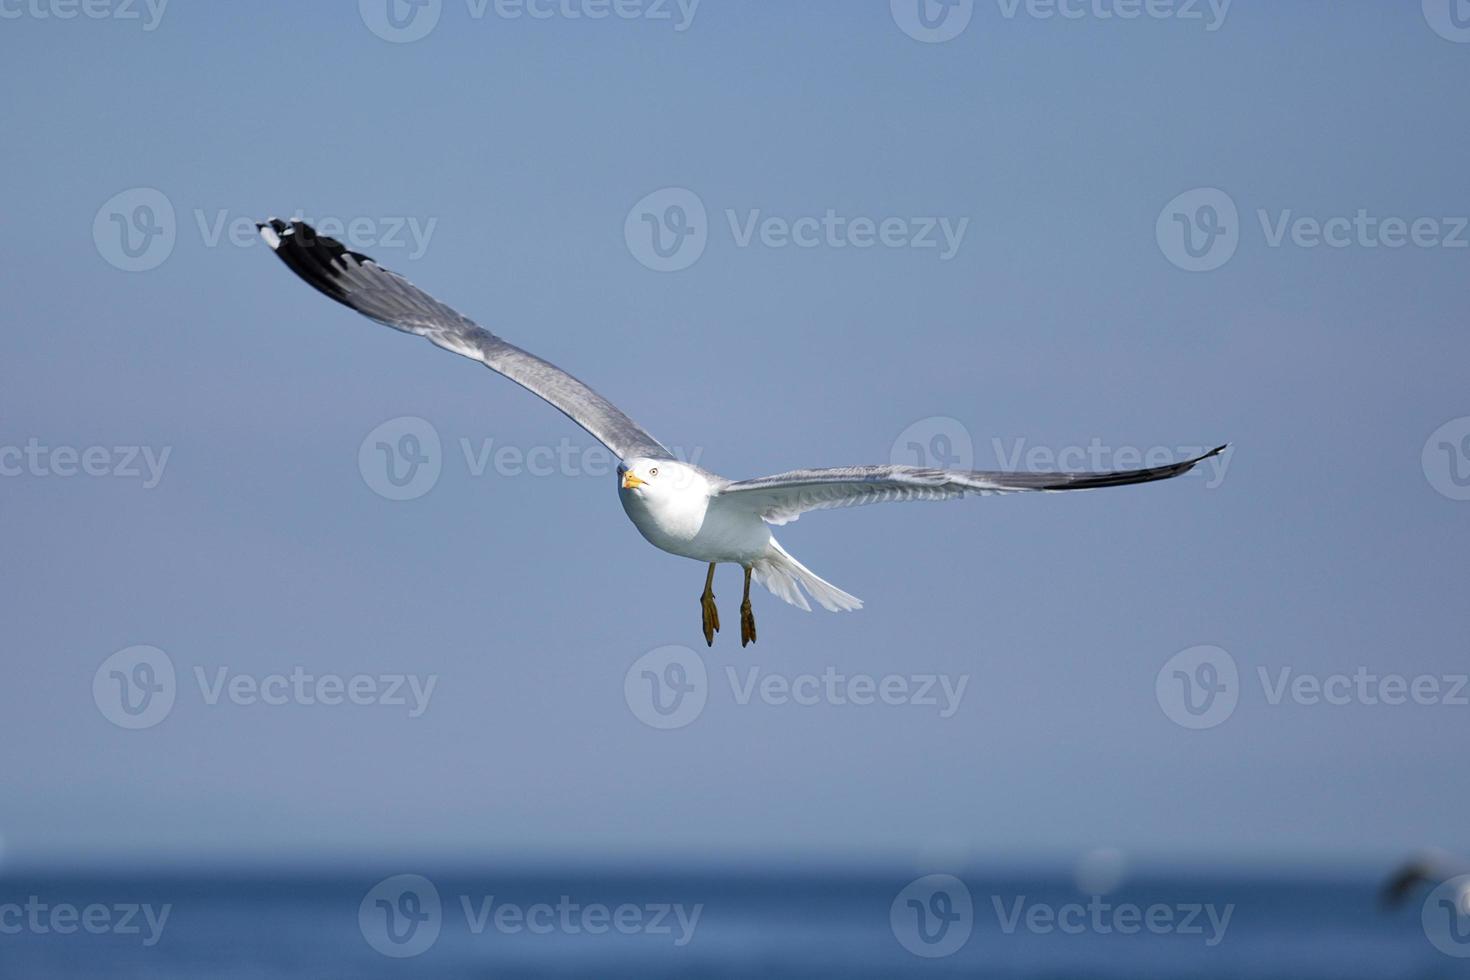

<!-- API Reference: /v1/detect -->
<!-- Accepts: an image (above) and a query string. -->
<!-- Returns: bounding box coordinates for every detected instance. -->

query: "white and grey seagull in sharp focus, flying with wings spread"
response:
[257,217,1226,646]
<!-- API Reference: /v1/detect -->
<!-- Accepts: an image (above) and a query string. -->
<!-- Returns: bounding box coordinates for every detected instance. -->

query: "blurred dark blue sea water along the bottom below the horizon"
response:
[0,870,1470,980]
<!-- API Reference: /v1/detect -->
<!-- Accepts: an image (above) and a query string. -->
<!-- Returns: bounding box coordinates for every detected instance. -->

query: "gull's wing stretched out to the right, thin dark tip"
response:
[719,445,1226,525]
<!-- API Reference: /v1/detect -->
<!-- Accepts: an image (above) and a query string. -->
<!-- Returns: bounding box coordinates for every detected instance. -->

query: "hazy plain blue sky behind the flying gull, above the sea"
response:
[0,0,1470,864]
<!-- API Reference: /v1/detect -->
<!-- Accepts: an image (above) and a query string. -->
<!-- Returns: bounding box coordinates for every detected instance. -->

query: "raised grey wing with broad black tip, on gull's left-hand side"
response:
[257,217,672,460]
